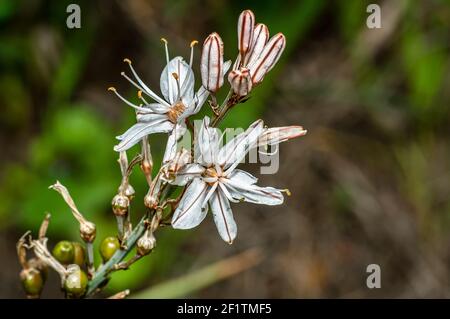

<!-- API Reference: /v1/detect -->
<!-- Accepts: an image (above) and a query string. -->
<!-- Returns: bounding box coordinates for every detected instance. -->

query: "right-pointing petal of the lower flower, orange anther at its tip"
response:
[225,177,284,206]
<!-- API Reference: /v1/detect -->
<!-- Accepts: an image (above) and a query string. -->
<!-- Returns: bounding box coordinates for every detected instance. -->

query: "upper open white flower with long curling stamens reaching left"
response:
[110,39,209,161]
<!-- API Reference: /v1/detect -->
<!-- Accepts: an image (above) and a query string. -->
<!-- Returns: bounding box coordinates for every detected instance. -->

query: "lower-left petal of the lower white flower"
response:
[172,178,209,229]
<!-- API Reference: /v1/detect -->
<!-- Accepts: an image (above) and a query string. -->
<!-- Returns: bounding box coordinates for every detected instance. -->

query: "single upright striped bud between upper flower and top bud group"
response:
[200,32,224,92]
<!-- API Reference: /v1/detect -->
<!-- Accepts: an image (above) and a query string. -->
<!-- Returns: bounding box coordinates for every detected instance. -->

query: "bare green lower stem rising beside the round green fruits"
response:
[86,217,147,296]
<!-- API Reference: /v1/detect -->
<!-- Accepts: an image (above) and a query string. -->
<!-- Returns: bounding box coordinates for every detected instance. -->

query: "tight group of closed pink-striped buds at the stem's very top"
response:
[228,10,286,96]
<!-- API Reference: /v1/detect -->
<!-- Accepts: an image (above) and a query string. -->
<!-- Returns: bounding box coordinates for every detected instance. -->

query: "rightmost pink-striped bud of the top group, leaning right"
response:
[249,33,286,85]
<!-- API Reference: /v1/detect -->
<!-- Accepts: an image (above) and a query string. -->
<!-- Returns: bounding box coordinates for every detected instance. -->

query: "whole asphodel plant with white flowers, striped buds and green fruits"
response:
[17,10,306,298]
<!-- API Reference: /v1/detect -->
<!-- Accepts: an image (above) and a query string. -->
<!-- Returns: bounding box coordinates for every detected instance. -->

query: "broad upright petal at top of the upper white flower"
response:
[160,56,194,104]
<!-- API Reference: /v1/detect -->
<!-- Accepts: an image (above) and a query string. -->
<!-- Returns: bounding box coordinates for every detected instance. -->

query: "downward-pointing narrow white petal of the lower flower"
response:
[209,189,237,244]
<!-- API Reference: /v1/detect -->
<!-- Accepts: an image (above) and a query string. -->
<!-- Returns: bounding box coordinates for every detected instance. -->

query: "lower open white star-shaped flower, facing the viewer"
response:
[172,117,284,244]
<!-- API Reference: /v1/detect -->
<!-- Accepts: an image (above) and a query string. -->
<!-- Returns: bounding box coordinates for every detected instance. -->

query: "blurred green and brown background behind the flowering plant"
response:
[0,0,450,298]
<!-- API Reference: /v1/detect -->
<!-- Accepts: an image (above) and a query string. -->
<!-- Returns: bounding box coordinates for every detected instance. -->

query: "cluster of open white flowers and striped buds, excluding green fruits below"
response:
[111,10,306,243]
